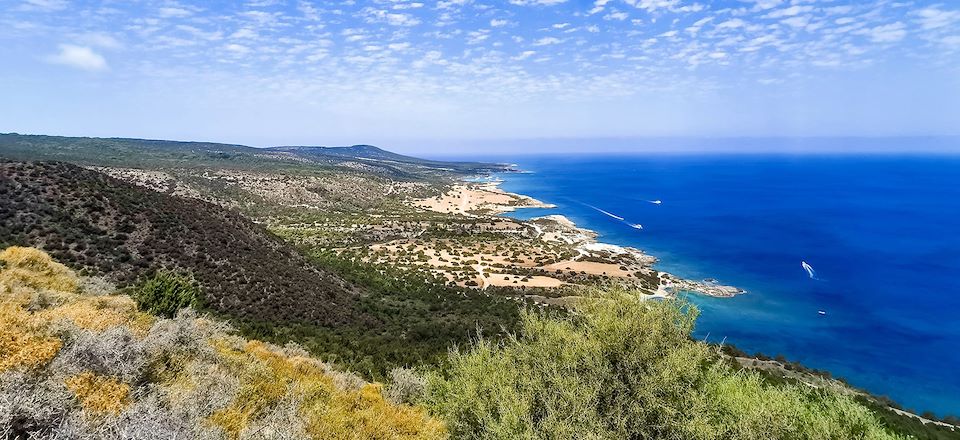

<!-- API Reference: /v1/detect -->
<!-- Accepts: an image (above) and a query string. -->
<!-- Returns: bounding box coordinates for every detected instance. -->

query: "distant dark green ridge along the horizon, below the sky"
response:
[0,133,509,178]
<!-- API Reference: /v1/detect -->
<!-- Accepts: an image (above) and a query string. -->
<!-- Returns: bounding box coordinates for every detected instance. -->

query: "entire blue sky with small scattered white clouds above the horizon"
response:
[0,0,960,153]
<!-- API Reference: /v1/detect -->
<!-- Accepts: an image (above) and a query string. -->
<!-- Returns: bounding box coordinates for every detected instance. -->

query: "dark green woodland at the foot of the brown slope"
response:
[232,251,524,379]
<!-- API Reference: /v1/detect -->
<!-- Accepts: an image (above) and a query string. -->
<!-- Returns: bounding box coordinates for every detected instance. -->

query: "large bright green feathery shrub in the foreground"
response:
[427,292,898,439]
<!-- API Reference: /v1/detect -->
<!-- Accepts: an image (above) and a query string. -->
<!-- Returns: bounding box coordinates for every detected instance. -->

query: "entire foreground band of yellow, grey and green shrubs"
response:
[0,247,920,439]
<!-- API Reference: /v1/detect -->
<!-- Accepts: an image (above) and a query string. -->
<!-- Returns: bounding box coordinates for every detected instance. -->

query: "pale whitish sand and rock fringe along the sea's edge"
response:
[428,176,746,298]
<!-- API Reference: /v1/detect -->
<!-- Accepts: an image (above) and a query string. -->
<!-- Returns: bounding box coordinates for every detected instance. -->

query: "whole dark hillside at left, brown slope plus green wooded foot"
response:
[0,160,519,377]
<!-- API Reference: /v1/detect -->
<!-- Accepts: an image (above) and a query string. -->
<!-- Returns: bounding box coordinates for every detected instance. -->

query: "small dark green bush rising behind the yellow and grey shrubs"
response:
[132,269,204,318]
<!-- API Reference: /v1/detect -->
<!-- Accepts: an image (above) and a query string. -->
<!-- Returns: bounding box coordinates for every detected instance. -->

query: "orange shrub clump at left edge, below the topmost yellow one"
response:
[0,302,63,372]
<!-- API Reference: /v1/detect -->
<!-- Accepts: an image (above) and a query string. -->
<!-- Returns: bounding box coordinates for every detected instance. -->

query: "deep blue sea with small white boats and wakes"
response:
[470,155,960,415]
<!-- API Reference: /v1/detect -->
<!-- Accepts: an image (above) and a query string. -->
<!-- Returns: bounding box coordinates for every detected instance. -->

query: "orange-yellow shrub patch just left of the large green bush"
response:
[211,341,446,440]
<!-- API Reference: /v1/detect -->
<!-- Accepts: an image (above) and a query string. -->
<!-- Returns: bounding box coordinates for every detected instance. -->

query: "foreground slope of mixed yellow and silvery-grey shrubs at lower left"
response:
[0,247,445,440]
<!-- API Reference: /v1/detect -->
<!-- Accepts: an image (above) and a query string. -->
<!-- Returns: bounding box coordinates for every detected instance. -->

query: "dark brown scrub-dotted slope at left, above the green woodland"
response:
[0,160,373,326]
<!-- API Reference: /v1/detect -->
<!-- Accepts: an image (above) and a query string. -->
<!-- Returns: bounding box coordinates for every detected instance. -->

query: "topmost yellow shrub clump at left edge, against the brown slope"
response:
[0,246,80,292]
